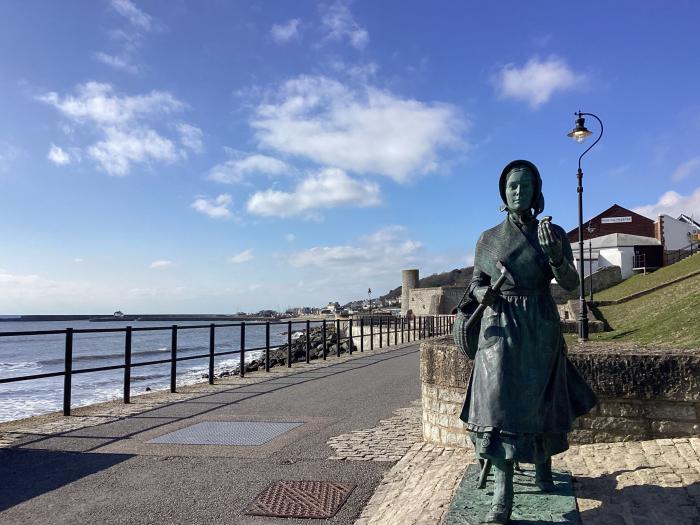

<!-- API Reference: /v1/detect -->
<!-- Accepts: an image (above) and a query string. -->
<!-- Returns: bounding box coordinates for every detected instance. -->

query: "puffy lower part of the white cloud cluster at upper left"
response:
[88,127,178,176]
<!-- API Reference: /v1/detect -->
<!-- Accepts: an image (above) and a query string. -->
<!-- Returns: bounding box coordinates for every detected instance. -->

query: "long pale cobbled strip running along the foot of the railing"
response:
[0,344,418,449]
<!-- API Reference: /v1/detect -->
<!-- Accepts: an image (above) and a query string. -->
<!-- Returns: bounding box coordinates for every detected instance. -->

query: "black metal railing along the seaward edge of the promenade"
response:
[0,315,454,416]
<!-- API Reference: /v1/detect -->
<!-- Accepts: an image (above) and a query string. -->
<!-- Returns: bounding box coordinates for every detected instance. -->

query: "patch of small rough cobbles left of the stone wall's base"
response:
[327,399,423,461]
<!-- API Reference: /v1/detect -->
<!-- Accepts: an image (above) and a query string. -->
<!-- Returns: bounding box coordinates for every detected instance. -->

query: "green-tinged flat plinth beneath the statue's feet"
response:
[443,464,581,525]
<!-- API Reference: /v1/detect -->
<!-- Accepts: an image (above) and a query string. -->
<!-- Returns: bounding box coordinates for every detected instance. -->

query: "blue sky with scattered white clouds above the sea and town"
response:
[0,0,700,314]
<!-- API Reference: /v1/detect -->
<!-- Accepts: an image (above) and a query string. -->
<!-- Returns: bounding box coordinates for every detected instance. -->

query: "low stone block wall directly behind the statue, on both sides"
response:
[420,337,700,447]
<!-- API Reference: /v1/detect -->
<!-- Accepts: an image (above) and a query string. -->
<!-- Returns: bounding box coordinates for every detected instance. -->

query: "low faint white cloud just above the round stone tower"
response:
[289,226,422,275]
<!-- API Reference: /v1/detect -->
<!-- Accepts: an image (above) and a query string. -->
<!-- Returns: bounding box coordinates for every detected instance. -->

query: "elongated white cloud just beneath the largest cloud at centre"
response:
[247,168,381,217]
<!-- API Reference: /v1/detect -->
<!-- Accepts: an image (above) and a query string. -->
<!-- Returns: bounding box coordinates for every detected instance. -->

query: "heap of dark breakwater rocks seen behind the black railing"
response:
[201,323,358,379]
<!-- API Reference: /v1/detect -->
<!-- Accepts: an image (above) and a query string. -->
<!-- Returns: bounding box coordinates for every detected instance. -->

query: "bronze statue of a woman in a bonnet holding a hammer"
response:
[460,160,596,524]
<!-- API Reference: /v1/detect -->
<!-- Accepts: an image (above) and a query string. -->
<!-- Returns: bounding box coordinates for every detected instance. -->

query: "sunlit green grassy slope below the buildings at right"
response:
[590,255,700,348]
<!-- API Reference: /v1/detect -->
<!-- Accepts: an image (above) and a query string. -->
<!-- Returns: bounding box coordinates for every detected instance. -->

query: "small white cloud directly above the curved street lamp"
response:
[494,56,586,108]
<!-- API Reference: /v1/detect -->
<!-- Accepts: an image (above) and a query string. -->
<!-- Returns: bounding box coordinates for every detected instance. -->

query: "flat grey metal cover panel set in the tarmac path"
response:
[148,421,302,446]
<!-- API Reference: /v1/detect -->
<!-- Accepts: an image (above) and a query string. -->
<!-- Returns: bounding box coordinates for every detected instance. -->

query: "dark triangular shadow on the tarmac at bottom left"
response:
[0,448,133,512]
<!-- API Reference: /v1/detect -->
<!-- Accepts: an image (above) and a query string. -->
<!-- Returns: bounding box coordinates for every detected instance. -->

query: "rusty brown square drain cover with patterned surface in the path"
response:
[246,481,355,519]
